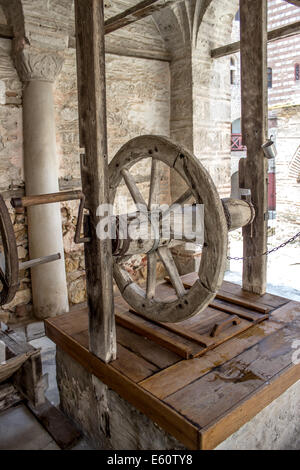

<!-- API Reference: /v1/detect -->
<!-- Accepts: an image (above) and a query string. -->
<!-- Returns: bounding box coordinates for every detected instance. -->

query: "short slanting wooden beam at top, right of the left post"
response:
[105,0,176,34]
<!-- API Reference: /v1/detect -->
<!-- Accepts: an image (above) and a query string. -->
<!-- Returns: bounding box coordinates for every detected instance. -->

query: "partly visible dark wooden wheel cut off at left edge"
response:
[0,195,19,305]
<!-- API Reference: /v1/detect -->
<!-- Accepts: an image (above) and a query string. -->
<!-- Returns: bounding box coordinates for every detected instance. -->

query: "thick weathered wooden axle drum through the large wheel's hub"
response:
[111,198,255,257]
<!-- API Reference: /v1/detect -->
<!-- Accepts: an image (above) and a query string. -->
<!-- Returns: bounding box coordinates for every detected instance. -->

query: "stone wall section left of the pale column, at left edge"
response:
[0,19,31,321]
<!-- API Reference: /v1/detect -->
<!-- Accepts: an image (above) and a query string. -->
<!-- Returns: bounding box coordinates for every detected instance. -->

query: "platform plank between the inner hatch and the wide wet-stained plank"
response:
[140,321,283,399]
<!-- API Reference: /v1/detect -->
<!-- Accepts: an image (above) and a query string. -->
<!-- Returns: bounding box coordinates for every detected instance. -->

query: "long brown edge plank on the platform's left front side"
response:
[45,319,198,450]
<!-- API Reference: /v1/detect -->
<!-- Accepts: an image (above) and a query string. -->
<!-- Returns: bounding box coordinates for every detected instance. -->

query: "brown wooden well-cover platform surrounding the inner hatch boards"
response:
[46,279,300,449]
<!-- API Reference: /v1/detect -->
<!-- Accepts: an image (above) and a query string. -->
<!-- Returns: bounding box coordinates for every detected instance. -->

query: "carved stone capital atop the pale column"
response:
[14,47,64,83]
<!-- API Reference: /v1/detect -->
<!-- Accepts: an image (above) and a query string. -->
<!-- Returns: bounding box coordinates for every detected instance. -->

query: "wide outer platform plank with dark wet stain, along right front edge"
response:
[164,326,300,428]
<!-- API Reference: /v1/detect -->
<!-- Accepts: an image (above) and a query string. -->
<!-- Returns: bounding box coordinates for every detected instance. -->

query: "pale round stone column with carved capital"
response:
[17,49,69,318]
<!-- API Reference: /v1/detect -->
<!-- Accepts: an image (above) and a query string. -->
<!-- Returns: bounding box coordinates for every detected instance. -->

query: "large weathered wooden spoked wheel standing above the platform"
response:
[109,136,228,323]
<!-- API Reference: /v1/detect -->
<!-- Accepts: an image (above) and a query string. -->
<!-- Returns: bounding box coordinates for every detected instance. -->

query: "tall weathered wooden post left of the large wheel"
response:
[75,0,116,362]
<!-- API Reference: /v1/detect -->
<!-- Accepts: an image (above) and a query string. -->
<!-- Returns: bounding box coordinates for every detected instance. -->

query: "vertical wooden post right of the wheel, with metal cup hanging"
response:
[240,0,268,294]
